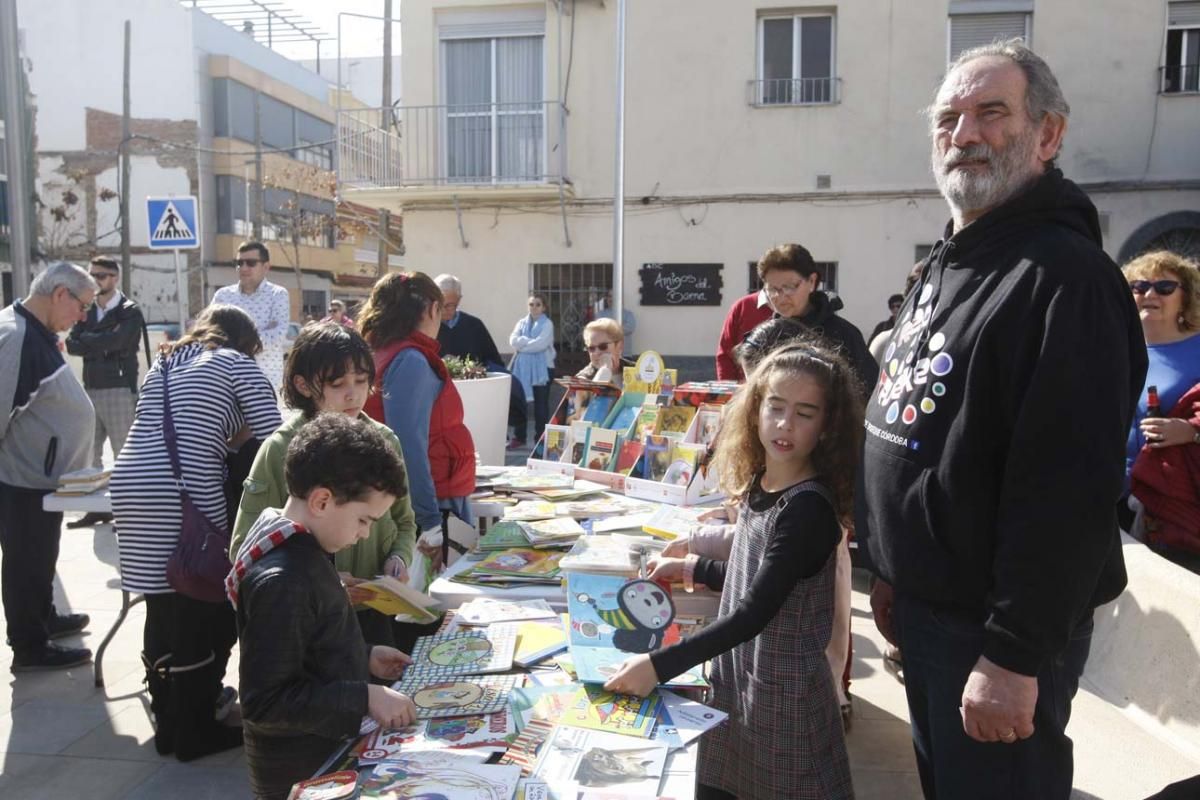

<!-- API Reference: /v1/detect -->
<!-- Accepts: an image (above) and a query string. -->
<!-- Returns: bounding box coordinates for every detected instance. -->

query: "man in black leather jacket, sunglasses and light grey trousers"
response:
[66,255,150,528]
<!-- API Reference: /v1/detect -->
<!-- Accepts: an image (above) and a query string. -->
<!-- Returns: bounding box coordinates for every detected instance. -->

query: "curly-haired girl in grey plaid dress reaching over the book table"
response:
[605,344,863,800]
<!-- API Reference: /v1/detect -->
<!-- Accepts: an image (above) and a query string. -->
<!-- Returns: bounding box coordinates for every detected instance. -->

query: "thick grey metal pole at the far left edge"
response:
[0,0,32,297]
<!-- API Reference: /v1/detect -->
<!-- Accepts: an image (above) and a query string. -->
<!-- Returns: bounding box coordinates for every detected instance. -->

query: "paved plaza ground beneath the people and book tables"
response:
[0,501,1200,800]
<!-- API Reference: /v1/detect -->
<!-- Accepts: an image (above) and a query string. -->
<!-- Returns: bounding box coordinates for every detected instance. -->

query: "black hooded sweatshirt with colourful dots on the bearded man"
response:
[856,169,1146,675]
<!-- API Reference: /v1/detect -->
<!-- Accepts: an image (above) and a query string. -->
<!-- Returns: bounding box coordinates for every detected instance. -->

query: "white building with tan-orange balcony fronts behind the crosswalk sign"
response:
[19,0,374,321]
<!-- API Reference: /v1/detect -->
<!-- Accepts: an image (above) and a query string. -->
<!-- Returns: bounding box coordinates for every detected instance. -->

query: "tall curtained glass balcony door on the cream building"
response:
[442,35,546,182]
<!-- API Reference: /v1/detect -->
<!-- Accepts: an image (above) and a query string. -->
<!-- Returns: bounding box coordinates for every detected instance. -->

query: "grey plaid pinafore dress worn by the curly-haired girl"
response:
[698,481,854,800]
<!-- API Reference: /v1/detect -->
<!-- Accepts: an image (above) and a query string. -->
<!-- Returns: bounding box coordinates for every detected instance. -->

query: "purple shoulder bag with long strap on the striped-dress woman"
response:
[162,357,232,603]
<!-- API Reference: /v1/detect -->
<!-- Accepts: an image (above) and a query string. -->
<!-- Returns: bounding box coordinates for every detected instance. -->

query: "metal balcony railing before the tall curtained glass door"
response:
[337,101,566,188]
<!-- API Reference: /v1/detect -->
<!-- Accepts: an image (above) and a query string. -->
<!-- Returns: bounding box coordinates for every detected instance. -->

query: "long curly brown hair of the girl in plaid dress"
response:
[714,341,863,521]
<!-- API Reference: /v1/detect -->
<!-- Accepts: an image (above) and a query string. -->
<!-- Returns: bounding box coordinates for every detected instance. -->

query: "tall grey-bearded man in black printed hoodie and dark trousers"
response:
[856,41,1146,800]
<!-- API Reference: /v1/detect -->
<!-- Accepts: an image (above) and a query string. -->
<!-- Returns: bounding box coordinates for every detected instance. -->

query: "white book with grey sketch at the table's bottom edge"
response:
[534,726,667,798]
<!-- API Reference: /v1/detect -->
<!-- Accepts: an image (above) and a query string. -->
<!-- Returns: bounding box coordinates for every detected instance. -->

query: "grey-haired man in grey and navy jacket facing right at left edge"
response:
[0,261,97,673]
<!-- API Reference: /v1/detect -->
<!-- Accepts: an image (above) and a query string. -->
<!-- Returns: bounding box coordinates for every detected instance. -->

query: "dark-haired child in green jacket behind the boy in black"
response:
[229,323,420,650]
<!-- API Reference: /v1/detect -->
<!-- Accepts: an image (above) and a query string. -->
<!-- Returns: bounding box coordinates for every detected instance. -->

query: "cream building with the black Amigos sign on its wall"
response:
[338,0,1200,367]
